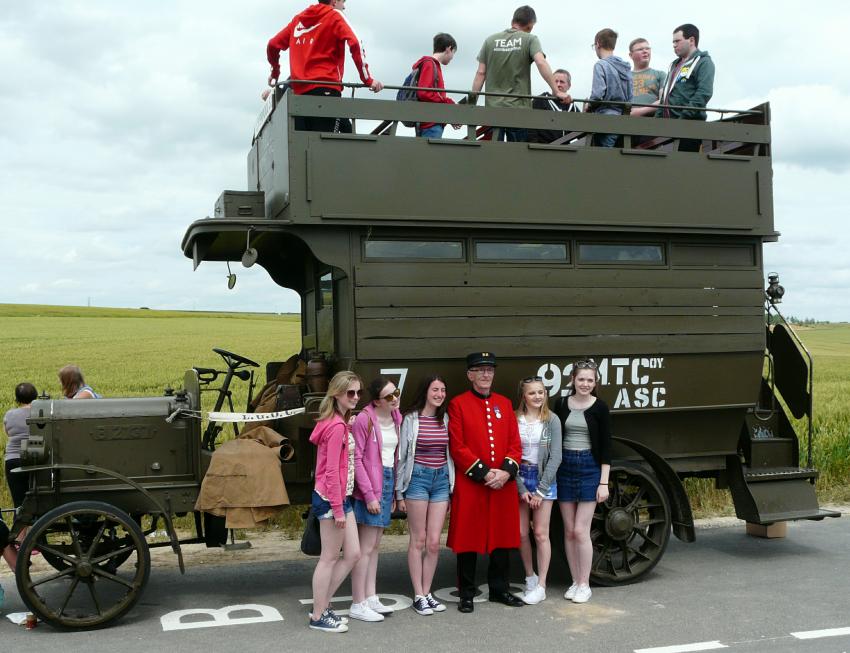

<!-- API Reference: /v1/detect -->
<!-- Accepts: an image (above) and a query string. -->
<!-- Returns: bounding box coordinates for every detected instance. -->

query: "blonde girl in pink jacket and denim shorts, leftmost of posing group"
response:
[310,372,362,633]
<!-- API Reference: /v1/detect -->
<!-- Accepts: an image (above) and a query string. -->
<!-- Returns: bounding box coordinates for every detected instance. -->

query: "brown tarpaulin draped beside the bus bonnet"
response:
[195,426,292,528]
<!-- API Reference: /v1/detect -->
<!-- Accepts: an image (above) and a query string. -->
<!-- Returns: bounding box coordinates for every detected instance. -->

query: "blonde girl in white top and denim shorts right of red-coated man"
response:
[516,376,561,605]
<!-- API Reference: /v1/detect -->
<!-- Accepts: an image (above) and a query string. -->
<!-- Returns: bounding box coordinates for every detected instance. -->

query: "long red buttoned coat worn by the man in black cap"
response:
[447,391,522,553]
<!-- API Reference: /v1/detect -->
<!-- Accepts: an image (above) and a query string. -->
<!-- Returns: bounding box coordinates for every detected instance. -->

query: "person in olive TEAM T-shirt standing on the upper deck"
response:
[472,5,572,142]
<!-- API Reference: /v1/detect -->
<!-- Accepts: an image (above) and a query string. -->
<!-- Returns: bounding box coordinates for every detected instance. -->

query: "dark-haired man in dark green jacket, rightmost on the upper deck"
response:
[655,23,714,120]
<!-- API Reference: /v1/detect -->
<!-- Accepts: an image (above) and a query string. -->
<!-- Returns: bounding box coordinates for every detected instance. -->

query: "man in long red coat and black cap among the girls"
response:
[448,352,523,612]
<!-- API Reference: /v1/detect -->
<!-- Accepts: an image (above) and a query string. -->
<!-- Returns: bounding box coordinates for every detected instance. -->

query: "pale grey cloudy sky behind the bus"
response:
[0,0,850,320]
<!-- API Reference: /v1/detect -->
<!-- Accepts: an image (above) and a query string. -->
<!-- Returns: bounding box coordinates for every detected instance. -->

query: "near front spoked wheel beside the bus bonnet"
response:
[16,501,151,629]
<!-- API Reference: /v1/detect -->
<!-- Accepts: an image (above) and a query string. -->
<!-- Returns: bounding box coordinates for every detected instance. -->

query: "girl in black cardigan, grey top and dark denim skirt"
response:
[555,359,611,603]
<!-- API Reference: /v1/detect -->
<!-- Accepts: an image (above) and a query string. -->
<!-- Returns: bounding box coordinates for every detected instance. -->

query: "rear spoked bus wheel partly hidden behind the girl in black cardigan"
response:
[590,463,671,586]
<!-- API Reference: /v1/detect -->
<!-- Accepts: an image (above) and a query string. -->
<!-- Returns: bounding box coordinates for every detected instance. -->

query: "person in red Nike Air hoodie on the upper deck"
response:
[266,0,384,132]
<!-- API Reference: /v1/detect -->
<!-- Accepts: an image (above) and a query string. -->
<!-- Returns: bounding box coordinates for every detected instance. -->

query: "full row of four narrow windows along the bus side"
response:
[364,240,756,266]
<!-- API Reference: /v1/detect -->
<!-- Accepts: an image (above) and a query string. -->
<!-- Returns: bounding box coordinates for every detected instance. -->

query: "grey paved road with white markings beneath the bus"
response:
[0,515,850,653]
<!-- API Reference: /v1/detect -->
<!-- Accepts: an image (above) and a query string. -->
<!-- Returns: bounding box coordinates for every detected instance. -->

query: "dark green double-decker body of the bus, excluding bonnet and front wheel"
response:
[182,89,834,584]
